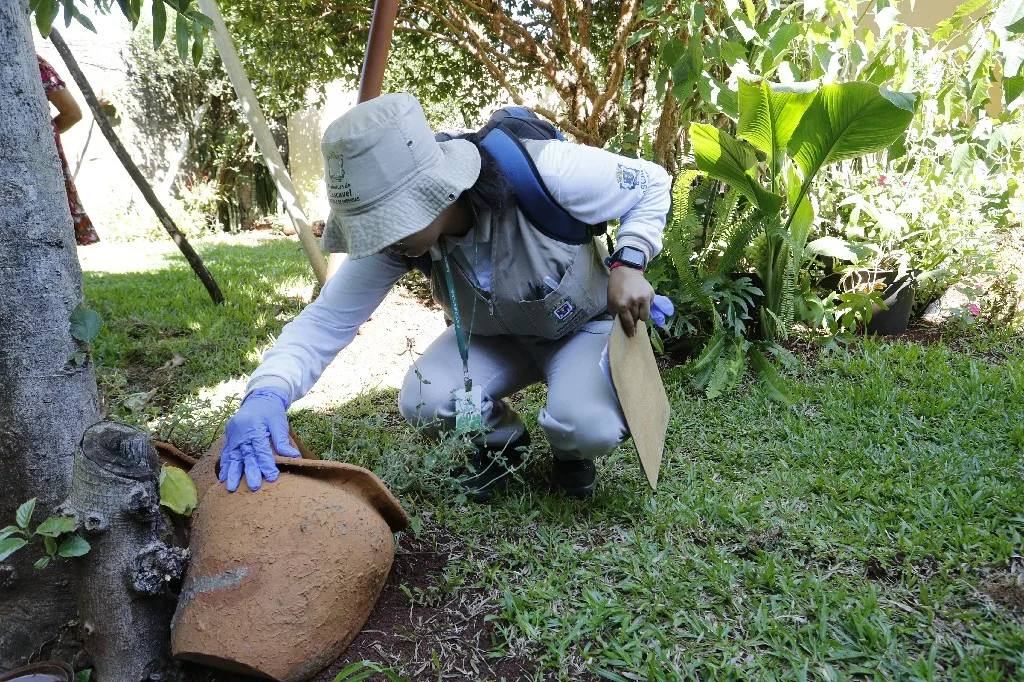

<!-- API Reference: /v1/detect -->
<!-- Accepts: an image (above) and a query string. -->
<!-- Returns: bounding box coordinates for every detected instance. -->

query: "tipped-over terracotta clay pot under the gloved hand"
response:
[171,441,409,682]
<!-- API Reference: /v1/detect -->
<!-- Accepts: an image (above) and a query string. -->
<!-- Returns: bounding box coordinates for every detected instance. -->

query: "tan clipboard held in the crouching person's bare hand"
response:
[608,315,670,491]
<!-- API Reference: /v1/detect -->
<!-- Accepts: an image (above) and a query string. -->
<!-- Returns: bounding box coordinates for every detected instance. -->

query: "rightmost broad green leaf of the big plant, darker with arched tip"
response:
[788,83,916,195]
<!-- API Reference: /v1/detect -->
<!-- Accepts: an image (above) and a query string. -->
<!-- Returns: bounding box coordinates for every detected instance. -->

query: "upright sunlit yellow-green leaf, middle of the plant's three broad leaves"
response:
[736,80,818,183]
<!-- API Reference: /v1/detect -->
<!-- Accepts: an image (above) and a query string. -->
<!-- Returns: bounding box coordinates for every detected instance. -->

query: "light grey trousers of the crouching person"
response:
[398,321,629,460]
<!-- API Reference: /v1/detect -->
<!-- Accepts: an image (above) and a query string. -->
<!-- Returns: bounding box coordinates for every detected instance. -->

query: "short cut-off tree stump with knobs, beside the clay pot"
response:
[60,422,186,682]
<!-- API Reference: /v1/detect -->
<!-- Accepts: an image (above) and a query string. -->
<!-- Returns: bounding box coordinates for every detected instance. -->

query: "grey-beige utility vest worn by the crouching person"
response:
[430,142,608,339]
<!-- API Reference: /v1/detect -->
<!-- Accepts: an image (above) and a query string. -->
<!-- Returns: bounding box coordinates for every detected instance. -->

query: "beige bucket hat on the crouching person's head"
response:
[321,92,480,258]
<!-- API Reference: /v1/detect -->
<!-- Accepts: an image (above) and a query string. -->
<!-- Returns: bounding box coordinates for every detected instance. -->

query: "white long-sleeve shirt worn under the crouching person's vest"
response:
[246,141,672,401]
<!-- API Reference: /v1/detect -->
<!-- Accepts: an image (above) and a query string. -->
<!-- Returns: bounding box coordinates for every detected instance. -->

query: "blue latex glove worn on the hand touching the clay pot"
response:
[219,388,302,493]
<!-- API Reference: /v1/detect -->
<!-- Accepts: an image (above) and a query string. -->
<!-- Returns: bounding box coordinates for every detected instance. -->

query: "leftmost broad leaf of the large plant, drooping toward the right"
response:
[690,123,782,213]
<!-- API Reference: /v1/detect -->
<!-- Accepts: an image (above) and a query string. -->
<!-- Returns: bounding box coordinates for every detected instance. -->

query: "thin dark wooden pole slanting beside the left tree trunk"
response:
[50,29,224,303]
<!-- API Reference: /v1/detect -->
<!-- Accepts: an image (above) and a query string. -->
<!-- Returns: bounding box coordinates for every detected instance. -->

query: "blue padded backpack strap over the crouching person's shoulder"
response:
[480,127,603,244]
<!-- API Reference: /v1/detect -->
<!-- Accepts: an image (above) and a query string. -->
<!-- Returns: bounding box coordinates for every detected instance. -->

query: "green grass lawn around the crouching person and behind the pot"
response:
[82,235,1024,681]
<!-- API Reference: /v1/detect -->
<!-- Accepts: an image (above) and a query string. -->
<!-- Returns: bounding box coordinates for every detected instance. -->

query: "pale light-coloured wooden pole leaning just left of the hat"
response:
[199,0,327,286]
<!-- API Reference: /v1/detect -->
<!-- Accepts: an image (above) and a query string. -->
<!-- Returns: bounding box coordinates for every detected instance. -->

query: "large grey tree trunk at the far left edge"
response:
[0,0,98,659]
